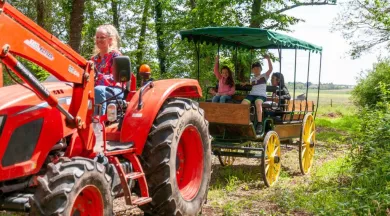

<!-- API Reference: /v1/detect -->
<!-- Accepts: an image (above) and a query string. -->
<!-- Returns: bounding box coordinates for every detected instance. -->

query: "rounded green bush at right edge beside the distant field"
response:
[352,59,390,107]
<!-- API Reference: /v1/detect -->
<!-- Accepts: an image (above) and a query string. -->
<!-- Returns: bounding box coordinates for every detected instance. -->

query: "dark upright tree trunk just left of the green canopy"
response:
[154,0,166,74]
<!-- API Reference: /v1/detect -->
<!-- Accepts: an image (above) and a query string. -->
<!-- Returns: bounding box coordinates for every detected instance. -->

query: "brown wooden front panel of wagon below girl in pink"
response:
[199,102,250,125]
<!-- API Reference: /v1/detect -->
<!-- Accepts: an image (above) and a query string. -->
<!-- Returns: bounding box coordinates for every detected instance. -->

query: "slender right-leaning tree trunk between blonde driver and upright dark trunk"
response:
[136,0,150,85]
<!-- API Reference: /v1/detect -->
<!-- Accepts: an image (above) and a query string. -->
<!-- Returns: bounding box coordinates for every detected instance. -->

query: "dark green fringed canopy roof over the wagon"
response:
[180,27,322,52]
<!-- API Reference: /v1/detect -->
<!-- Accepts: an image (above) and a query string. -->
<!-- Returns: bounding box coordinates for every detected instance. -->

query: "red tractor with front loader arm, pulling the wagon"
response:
[0,1,211,216]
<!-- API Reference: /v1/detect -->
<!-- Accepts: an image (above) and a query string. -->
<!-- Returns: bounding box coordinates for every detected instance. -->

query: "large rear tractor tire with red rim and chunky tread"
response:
[140,98,211,215]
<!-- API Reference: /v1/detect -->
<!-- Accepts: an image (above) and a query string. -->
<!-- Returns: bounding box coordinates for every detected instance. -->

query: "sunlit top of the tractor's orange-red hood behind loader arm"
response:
[0,82,72,114]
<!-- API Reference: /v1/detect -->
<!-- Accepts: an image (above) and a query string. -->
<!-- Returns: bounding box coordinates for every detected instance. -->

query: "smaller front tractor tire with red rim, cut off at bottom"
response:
[30,157,113,216]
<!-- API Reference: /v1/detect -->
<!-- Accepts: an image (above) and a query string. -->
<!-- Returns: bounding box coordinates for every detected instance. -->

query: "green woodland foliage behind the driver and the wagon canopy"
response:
[2,0,334,87]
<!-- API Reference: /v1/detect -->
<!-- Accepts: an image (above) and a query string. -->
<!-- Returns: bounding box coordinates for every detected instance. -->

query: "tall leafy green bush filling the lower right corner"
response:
[350,82,390,215]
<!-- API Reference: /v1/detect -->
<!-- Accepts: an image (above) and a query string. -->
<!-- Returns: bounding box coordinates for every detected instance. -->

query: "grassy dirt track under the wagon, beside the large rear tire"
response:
[115,143,346,216]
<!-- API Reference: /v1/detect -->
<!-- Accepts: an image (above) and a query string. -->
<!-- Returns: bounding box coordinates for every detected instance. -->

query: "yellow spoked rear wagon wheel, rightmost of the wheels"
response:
[299,113,317,175]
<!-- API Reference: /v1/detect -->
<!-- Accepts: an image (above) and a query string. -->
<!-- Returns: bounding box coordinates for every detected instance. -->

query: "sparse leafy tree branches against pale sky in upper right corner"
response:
[333,0,390,59]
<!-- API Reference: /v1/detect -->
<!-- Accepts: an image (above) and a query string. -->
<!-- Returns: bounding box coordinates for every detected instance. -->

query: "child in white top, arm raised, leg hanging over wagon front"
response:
[242,55,273,134]
